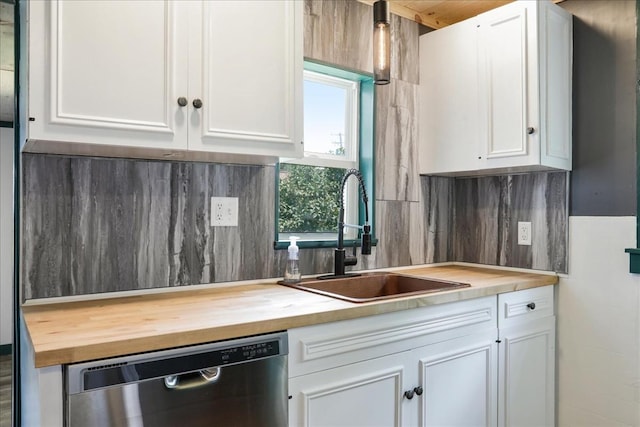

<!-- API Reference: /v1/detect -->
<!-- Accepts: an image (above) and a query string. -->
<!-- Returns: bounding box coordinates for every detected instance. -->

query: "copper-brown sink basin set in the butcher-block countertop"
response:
[280,272,471,302]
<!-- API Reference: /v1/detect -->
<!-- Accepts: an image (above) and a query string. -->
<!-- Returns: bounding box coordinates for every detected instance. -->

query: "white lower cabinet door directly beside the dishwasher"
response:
[289,352,415,427]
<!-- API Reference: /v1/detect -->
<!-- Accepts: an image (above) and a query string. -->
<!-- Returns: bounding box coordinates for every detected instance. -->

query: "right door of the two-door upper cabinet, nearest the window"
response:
[189,1,303,157]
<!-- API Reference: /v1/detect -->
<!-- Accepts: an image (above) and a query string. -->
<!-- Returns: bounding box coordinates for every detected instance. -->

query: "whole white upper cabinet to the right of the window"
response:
[420,1,572,175]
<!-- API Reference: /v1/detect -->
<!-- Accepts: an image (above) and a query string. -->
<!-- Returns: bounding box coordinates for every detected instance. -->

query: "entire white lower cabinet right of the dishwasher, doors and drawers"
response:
[289,286,555,427]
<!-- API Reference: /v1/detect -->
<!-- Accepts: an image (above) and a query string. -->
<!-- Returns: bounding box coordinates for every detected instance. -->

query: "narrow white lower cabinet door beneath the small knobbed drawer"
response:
[498,316,556,427]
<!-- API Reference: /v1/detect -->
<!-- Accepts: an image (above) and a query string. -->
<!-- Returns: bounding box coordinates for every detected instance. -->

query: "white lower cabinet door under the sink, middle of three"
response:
[413,330,498,427]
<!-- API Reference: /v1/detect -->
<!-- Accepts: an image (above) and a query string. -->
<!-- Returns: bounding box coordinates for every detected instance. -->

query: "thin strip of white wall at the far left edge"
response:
[0,128,13,344]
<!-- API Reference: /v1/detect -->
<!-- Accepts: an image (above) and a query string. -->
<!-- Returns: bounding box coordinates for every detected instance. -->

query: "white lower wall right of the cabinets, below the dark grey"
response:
[557,216,640,427]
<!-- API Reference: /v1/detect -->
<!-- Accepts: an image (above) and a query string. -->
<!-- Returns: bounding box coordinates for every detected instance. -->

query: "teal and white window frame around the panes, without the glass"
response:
[274,59,377,249]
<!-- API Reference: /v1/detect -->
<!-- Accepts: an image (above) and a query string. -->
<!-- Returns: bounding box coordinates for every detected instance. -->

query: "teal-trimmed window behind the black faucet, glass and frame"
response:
[276,62,373,248]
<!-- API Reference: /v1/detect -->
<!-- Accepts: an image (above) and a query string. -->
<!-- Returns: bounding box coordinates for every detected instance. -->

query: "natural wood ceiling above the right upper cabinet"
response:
[358,0,564,29]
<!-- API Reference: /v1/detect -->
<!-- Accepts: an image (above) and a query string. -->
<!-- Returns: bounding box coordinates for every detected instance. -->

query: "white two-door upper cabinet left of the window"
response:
[26,0,303,162]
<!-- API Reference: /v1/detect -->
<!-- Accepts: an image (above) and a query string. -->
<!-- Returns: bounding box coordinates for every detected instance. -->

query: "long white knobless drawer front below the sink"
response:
[289,296,497,378]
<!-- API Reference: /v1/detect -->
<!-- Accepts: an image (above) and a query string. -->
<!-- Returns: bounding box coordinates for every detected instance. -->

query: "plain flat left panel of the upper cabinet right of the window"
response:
[418,19,481,174]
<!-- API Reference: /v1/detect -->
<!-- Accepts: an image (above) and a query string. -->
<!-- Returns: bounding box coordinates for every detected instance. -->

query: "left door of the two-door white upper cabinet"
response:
[28,0,188,149]
